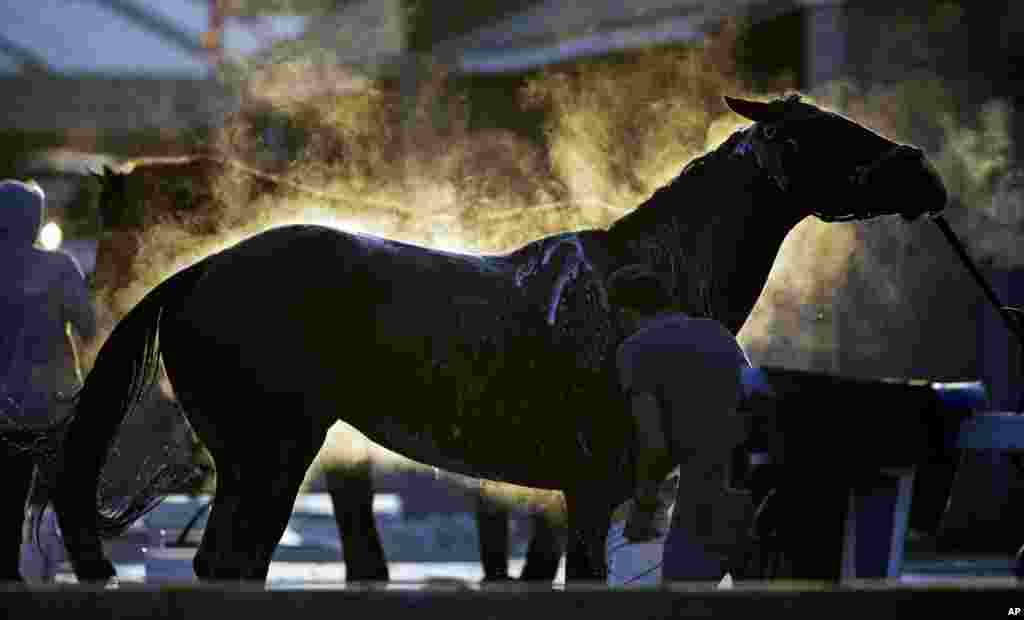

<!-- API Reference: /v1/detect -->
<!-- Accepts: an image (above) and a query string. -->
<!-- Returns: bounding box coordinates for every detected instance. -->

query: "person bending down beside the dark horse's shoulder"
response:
[608,265,752,581]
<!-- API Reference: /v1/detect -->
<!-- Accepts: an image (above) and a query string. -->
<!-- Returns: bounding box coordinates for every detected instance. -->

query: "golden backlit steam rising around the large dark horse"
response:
[88,12,1024,501]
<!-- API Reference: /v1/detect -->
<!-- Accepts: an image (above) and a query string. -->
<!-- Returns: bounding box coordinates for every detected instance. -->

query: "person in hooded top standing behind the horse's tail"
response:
[0,180,96,580]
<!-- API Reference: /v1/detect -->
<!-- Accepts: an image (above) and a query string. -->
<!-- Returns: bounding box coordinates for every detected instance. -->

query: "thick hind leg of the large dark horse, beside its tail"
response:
[194,422,324,581]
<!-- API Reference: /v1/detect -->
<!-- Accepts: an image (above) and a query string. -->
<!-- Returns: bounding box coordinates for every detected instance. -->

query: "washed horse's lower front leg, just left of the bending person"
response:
[565,490,612,585]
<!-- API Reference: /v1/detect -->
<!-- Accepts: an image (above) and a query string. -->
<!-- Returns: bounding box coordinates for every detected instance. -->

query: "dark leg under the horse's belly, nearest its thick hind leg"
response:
[324,461,390,581]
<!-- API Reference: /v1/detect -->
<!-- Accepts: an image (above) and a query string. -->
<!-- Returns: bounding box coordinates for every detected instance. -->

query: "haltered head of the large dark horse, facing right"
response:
[725,95,946,221]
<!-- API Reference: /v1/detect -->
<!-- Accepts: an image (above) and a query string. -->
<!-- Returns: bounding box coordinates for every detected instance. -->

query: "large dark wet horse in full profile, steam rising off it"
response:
[46,96,946,581]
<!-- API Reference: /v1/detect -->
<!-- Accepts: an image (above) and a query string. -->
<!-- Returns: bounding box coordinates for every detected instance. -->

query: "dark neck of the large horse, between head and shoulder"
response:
[609,161,801,333]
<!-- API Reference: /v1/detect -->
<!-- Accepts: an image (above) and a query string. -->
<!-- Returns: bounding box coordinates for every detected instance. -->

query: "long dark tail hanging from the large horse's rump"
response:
[48,261,205,552]
